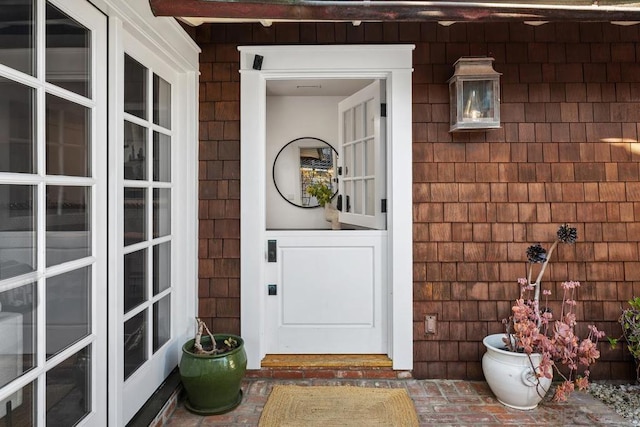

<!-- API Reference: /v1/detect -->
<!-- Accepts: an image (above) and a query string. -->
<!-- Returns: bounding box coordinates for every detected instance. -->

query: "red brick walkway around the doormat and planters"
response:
[160,378,631,427]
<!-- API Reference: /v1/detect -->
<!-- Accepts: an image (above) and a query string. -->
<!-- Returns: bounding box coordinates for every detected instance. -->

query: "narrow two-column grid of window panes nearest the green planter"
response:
[122,54,172,380]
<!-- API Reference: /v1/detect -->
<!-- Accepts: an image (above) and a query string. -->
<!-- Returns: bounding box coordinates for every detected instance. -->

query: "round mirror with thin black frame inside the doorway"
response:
[273,136,338,208]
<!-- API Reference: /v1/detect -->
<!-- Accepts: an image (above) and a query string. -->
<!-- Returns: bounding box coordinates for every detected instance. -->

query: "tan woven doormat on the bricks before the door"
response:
[258,385,418,427]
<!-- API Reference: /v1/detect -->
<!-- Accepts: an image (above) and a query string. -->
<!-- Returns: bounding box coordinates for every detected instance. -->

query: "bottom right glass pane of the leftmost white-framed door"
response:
[45,347,91,426]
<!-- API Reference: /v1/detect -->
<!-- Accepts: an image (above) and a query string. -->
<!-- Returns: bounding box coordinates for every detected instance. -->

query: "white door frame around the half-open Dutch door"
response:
[238,45,414,370]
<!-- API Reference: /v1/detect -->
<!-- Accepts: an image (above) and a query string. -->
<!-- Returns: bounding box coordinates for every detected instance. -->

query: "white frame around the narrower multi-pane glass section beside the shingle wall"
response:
[101,0,200,426]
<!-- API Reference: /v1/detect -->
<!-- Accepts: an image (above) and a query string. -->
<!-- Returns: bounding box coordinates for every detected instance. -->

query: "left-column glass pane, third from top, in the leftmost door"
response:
[0,185,36,280]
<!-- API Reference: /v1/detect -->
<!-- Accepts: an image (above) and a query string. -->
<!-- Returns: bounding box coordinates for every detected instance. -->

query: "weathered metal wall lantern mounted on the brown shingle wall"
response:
[449,57,500,132]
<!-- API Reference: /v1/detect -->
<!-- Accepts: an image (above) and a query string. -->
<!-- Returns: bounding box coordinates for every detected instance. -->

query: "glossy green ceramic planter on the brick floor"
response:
[180,334,247,415]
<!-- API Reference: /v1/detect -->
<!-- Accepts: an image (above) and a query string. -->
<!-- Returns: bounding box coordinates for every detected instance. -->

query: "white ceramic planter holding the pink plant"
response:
[482,334,551,410]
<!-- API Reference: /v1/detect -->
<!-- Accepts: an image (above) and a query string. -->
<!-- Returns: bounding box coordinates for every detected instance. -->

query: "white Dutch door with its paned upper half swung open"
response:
[265,81,388,354]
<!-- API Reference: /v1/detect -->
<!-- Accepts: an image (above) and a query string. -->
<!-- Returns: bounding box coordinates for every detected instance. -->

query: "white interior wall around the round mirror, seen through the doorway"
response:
[266,96,344,230]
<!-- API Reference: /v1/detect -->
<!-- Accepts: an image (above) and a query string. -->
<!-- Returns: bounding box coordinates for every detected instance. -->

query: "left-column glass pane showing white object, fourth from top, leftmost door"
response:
[0,283,37,392]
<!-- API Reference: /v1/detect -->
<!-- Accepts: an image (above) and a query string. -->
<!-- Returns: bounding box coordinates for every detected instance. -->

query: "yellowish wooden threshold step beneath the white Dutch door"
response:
[261,354,393,369]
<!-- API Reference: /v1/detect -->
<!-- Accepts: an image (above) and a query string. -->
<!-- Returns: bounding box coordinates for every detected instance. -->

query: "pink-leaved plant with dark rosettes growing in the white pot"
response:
[503,224,604,402]
